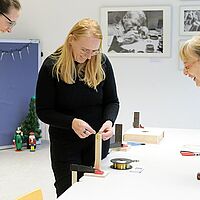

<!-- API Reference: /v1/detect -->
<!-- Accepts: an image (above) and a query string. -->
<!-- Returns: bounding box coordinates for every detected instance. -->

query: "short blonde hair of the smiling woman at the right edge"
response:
[179,35,200,61]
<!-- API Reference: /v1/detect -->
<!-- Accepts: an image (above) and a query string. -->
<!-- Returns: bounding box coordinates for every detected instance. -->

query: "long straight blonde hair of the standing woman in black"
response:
[51,18,105,89]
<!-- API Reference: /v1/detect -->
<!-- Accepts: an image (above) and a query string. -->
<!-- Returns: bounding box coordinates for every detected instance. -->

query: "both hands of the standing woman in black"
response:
[72,118,113,141]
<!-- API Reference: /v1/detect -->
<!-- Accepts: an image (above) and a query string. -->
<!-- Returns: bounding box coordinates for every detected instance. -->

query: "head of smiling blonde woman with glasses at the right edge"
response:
[180,35,200,87]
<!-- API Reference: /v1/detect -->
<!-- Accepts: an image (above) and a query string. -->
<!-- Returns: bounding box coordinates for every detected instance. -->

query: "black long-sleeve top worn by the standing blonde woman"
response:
[36,55,119,140]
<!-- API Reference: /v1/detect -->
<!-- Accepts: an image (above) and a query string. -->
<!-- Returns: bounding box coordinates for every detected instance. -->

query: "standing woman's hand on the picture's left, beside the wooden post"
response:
[72,118,96,138]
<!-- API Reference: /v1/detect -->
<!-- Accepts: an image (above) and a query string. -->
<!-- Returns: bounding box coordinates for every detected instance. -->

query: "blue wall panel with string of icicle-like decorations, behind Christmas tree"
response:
[0,41,40,146]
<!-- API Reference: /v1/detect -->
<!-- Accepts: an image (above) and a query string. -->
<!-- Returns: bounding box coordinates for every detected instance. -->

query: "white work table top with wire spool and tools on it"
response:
[58,128,200,200]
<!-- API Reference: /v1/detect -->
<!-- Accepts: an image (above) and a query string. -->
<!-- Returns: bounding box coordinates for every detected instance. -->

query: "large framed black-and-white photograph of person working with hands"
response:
[101,6,171,57]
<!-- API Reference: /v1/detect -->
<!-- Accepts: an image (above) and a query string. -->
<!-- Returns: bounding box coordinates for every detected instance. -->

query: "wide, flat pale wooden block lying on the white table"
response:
[123,128,164,144]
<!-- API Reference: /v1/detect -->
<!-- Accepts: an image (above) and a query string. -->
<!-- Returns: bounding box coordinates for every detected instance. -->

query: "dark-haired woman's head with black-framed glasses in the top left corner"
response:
[0,0,21,32]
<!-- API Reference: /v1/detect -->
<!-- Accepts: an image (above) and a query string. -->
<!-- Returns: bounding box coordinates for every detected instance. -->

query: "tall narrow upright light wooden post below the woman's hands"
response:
[94,133,102,170]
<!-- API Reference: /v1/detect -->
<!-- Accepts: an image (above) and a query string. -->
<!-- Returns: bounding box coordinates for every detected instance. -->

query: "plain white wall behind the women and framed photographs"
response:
[0,0,200,134]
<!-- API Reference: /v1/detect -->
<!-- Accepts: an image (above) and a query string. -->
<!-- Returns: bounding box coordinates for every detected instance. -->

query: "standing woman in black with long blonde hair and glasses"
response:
[36,19,119,196]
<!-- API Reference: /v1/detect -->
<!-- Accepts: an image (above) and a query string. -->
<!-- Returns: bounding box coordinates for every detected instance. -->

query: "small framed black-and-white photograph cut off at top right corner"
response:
[180,5,200,35]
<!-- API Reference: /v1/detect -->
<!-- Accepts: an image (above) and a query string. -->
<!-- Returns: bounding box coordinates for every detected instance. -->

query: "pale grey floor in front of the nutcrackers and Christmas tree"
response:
[0,140,56,200]
